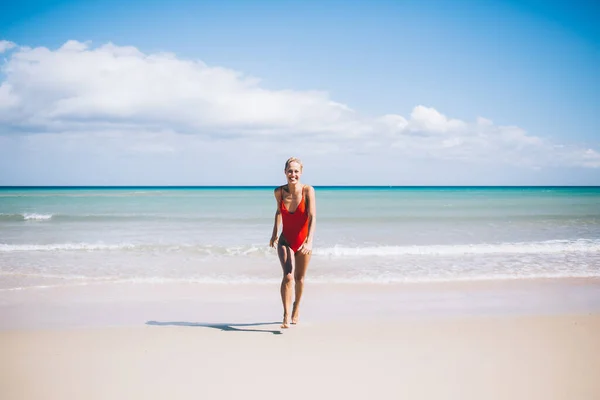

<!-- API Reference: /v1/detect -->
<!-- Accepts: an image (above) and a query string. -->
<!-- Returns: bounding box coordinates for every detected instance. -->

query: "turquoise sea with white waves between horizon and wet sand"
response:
[0,187,600,290]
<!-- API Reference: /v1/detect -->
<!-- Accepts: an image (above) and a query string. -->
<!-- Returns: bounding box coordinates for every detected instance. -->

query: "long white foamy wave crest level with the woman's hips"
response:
[0,239,600,258]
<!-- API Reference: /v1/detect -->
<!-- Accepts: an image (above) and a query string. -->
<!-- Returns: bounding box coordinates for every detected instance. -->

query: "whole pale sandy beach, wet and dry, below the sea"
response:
[0,280,600,400]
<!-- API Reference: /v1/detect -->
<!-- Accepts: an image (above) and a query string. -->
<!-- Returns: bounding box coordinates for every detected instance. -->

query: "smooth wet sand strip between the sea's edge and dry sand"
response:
[0,277,600,331]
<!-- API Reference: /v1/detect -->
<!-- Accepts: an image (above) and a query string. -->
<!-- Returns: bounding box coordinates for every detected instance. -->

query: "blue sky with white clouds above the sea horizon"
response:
[0,0,600,185]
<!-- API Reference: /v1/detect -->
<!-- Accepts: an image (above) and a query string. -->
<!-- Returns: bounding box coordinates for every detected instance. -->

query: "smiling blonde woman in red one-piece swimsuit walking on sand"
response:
[270,157,316,328]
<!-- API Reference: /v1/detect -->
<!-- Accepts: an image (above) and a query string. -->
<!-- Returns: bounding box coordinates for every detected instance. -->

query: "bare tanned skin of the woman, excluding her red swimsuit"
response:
[270,162,317,328]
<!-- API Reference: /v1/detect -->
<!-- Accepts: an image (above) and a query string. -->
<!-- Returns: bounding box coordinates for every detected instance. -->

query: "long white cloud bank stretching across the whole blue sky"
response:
[0,41,600,178]
